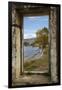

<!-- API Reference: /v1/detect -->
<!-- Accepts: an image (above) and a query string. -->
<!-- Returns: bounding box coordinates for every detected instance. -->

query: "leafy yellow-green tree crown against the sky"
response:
[34,27,49,49]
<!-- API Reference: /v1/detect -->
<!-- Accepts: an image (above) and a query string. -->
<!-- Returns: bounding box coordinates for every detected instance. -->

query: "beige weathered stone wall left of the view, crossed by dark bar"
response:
[12,6,22,80]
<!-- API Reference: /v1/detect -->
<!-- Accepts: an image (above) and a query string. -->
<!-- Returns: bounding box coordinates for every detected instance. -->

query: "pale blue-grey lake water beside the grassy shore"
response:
[24,46,41,60]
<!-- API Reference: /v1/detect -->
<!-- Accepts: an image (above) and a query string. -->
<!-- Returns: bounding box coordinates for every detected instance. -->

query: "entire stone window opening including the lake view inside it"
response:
[9,3,59,85]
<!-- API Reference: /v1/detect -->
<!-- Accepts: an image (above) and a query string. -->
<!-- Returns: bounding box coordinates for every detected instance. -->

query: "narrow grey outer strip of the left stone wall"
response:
[12,9,16,80]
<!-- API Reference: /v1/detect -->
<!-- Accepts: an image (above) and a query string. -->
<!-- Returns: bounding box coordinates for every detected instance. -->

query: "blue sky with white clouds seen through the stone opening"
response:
[23,16,49,39]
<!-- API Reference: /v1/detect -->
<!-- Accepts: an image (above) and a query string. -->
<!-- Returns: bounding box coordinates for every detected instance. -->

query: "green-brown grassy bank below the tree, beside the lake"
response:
[24,48,49,71]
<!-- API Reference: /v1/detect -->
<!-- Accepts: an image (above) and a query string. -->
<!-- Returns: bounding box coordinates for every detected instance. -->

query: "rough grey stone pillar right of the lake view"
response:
[50,7,57,82]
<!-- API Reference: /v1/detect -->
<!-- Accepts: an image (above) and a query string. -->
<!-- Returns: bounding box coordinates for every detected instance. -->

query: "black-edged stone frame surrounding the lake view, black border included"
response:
[8,2,60,88]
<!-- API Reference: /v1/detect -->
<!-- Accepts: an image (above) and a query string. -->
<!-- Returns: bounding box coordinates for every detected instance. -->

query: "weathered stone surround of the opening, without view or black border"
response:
[8,3,59,85]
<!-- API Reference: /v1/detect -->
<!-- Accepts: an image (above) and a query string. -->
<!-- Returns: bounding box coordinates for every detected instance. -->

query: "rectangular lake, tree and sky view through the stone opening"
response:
[23,15,49,73]
